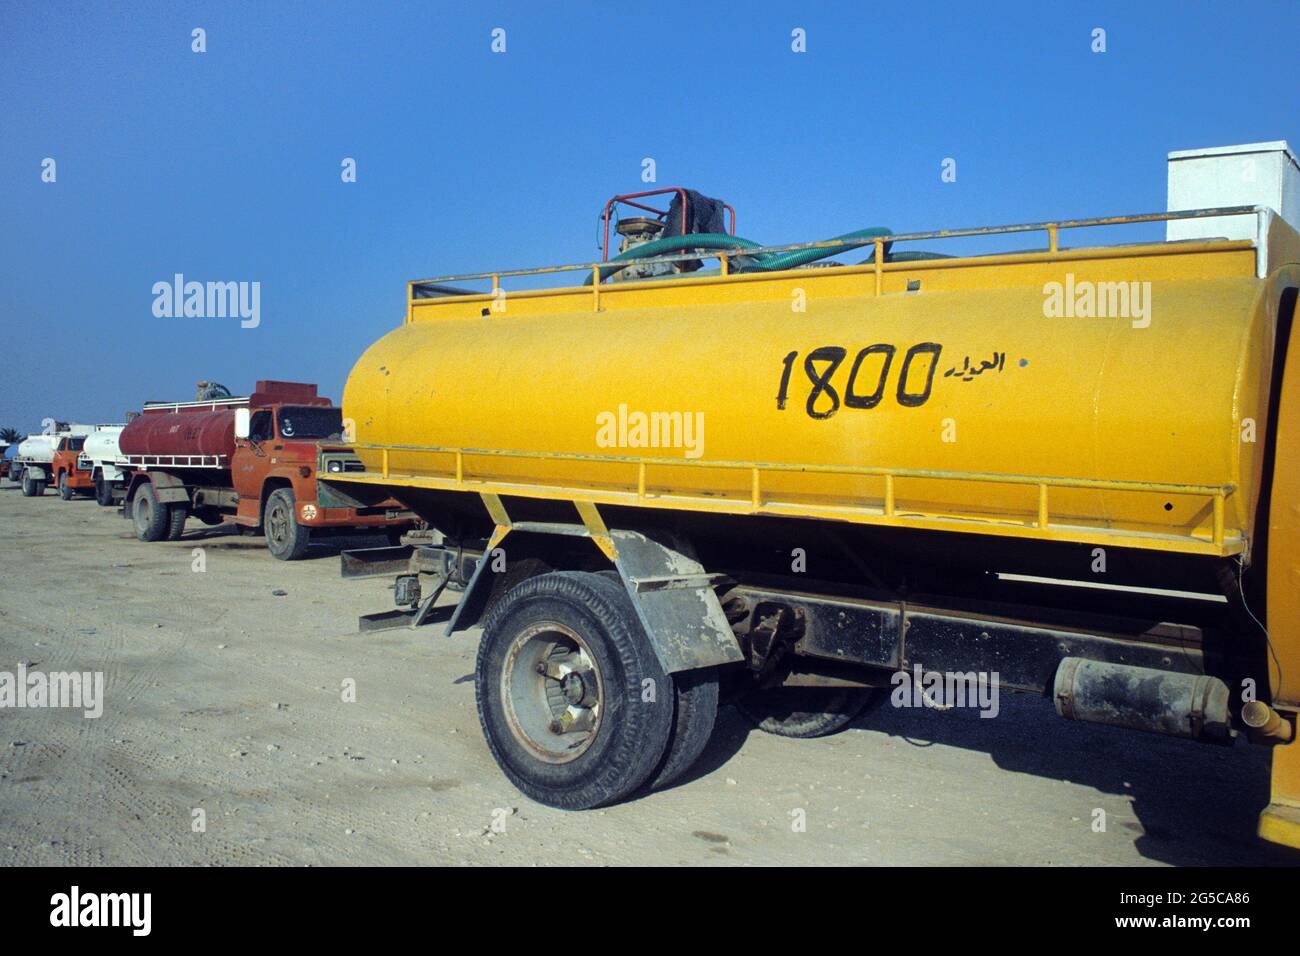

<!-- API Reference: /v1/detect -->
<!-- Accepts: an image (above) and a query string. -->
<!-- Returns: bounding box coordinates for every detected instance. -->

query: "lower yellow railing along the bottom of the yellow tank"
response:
[351,442,1236,549]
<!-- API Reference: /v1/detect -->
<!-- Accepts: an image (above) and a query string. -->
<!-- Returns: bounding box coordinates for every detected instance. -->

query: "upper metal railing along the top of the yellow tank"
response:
[407,206,1268,304]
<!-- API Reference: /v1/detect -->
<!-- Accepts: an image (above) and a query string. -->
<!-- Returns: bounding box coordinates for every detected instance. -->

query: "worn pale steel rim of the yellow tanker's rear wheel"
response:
[501,620,605,763]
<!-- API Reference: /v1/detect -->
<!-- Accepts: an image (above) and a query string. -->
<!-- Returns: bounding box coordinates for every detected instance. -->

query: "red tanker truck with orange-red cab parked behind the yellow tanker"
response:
[118,381,413,561]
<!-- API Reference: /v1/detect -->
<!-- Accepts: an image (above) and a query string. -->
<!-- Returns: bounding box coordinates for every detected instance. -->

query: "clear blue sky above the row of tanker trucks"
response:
[0,0,1300,431]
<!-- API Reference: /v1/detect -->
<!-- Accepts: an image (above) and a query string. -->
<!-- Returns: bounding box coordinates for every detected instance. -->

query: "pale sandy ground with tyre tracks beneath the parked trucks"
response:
[0,481,1300,865]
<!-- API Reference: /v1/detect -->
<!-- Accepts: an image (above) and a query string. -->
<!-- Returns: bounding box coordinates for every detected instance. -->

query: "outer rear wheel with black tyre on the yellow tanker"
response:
[475,571,673,810]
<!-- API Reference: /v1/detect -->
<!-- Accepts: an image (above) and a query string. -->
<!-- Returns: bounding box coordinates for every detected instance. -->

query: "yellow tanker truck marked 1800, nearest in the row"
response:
[334,143,1300,845]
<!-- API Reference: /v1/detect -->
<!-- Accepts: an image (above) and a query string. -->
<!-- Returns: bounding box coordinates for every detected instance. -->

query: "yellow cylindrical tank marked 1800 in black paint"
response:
[343,234,1279,555]
